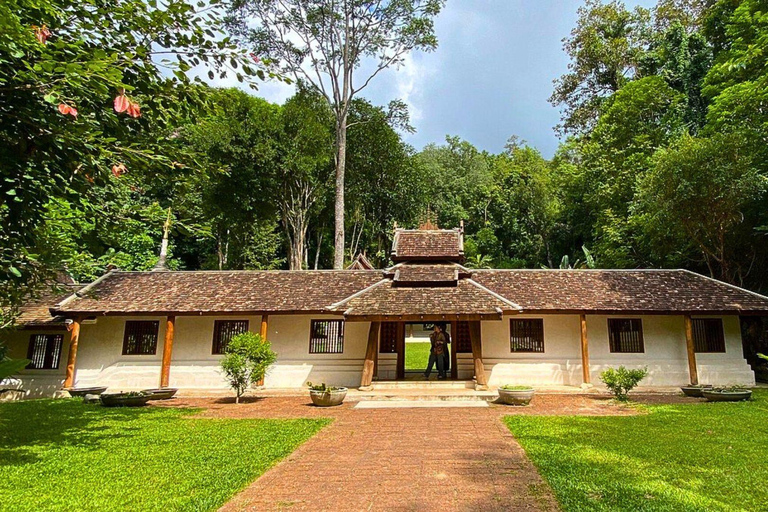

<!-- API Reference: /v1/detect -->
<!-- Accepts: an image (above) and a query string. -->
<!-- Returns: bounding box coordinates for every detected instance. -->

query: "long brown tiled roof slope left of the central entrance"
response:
[54,270,381,314]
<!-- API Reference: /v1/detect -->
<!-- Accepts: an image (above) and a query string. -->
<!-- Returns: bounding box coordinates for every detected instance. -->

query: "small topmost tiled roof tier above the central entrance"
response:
[392,229,464,261]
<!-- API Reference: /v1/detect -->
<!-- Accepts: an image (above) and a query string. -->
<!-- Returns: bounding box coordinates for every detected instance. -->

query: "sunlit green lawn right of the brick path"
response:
[504,390,768,511]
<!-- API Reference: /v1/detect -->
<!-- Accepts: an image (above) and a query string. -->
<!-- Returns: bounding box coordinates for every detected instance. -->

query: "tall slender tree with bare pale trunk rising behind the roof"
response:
[229,0,444,268]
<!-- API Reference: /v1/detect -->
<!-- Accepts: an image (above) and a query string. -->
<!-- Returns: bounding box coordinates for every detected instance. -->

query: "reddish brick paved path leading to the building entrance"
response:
[158,395,674,512]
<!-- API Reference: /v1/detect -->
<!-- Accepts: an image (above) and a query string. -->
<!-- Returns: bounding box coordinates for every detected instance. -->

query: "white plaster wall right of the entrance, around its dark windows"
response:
[482,315,755,386]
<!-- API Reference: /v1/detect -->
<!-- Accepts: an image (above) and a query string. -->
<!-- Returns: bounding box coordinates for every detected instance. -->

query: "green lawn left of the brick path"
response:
[0,399,328,511]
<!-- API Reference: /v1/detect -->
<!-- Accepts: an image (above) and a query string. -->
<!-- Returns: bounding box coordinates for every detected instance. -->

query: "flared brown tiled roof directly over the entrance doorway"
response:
[329,279,517,319]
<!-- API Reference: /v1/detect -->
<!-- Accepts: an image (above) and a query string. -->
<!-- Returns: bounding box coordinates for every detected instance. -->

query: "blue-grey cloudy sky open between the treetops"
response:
[220,0,655,158]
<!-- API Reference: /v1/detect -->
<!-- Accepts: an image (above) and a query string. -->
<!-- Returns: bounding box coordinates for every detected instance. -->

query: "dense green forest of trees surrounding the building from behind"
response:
[0,0,768,324]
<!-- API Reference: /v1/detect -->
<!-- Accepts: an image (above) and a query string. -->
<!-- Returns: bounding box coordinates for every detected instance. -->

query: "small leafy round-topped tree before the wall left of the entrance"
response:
[221,332,277,403]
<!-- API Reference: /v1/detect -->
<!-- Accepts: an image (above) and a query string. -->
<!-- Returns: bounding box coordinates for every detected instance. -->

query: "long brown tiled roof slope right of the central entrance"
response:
[472,270,768,313]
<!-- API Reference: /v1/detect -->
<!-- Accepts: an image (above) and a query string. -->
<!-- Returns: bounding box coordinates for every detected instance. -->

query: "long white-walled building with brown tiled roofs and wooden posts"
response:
[1,229,768,396]
